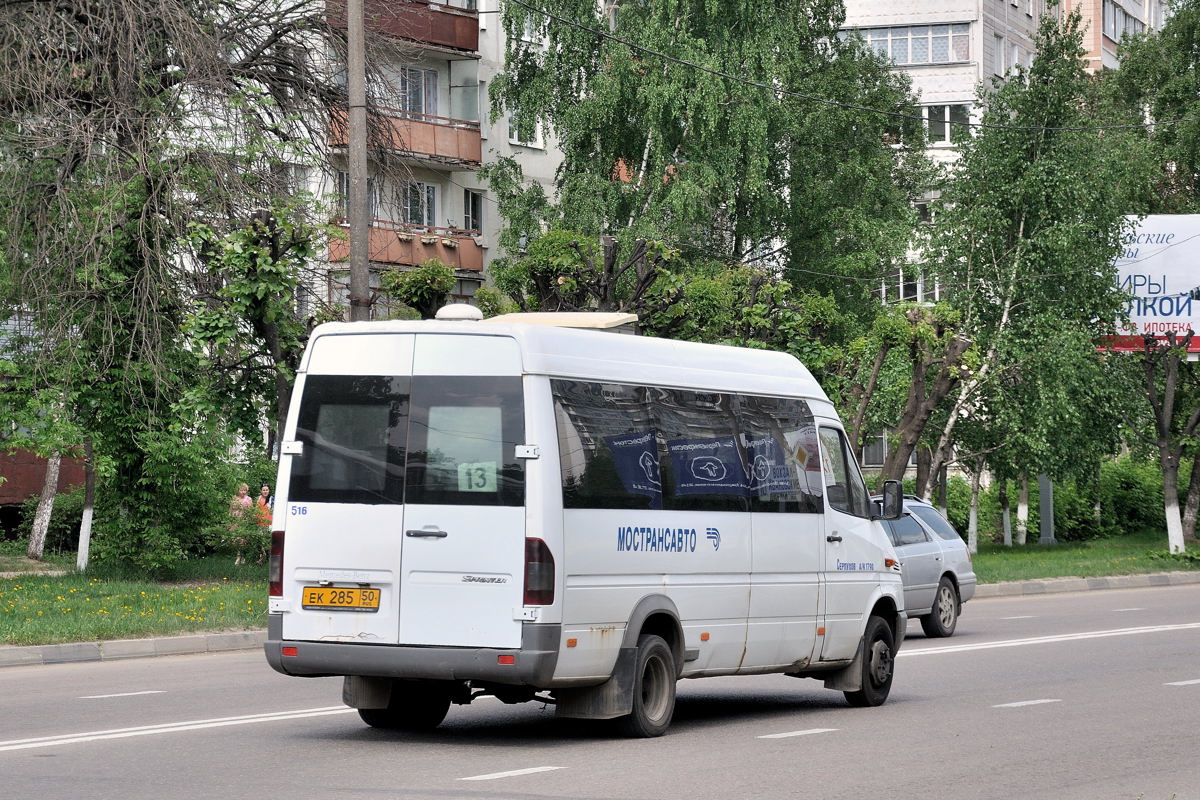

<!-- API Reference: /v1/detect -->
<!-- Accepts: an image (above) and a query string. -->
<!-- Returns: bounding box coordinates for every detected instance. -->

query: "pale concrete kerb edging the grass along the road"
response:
[7,572,1200,667]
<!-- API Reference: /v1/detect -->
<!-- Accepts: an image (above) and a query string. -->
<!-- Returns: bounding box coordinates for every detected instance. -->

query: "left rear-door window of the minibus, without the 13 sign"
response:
[289,375,409,505]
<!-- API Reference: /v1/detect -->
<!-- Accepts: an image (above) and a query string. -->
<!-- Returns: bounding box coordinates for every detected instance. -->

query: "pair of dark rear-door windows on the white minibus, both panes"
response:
[289,375,524,505]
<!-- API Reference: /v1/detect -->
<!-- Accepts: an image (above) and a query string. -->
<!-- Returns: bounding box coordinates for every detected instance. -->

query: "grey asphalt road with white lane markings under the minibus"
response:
[0,584,1200,800]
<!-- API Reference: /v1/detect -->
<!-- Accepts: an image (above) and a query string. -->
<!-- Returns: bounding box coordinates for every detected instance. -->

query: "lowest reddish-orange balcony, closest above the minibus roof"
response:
[329,219,484,272]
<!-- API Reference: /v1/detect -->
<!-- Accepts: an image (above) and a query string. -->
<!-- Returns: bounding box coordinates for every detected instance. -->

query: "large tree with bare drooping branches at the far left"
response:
[0,0,417,567]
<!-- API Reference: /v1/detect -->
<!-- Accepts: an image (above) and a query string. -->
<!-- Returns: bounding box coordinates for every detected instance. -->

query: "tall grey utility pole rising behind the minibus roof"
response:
[346,0,371,323]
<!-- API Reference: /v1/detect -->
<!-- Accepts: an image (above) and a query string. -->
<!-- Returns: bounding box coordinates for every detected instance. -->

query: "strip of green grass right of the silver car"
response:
[972,531,1200,583]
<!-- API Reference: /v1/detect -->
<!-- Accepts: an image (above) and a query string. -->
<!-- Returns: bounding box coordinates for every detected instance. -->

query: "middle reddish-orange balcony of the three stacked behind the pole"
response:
[329,109,484,168]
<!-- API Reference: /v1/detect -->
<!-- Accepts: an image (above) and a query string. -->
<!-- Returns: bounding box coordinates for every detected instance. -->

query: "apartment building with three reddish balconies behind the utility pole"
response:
[323,0,559,317]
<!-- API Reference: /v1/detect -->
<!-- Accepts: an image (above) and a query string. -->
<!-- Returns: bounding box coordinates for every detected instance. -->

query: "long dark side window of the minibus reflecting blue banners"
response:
[551,380,822,513]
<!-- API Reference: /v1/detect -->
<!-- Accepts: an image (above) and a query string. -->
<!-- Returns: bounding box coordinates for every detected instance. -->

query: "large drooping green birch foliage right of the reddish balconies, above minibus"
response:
[488,0,928,339]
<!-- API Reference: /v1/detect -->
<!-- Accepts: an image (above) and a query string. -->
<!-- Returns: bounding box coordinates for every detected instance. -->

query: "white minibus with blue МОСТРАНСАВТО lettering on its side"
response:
[265,305,906,736]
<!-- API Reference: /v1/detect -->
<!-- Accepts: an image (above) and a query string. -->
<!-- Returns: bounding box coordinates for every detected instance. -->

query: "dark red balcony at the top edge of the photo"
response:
[325,0,479,54]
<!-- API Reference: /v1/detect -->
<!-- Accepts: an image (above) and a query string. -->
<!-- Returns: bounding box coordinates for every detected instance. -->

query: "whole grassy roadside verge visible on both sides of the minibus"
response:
[0,533,1200,645]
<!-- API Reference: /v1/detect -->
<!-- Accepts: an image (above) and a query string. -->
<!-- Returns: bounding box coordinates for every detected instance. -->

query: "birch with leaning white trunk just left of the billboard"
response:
[926,11,1151,506]
